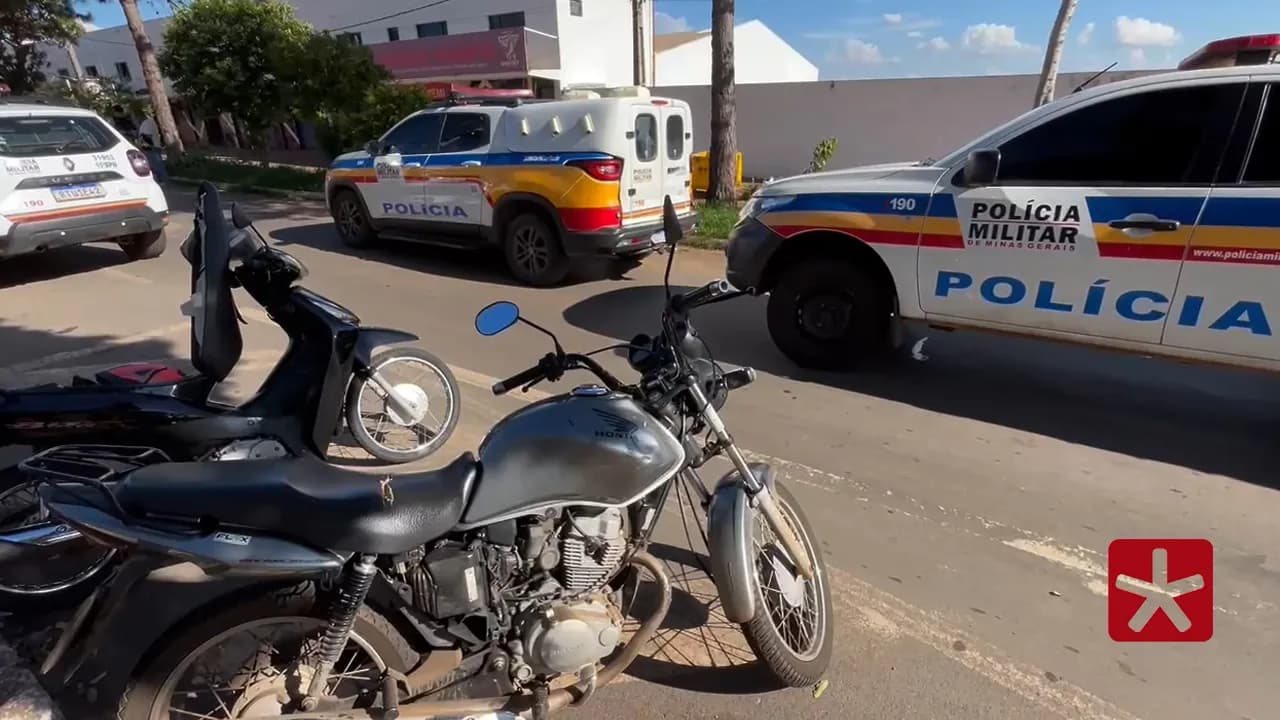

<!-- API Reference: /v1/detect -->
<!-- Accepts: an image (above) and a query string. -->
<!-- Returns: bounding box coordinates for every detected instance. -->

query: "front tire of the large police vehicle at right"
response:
[767,259,892,370]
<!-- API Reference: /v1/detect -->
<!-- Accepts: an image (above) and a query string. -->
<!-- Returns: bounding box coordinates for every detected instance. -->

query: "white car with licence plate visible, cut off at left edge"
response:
[0,100,169,260]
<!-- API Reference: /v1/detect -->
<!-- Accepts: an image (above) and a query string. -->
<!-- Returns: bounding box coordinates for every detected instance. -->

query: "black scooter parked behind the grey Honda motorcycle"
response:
[0,183,461,611]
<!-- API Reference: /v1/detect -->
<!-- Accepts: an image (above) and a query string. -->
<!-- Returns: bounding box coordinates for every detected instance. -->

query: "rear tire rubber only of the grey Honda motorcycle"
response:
[115,583,420,720]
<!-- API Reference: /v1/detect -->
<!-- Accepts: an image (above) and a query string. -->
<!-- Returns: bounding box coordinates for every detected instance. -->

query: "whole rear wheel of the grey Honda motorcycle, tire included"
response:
[116,587,419,720]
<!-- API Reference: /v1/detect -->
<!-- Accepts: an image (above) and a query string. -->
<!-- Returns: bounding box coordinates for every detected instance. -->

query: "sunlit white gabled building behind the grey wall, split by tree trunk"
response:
[655,20,818,87]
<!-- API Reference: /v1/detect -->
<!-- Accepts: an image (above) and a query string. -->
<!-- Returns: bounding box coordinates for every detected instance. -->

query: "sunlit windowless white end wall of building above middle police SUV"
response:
[556,0,635,86]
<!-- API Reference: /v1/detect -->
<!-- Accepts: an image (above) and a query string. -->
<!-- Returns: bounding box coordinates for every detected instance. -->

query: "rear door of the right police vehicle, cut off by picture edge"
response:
[1164,81,1280,360]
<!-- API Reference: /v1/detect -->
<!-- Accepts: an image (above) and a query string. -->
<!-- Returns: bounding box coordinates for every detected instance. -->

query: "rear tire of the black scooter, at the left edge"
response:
[0,483,118,614]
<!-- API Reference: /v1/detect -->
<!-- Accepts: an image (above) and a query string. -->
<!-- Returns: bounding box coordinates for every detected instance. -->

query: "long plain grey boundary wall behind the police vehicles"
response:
[653,70,1149,178]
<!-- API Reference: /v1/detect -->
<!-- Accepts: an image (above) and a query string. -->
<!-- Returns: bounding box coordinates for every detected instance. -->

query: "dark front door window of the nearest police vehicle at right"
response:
[998,83,1244,186]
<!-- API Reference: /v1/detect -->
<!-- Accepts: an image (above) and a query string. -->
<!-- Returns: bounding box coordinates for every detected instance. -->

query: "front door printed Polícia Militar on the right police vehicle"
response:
[918,78,1244,345]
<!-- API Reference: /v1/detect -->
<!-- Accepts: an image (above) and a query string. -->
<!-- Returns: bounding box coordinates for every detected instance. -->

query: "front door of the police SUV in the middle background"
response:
[362,113,443,227]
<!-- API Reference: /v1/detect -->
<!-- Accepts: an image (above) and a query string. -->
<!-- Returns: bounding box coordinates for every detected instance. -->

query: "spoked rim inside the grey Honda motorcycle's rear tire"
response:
[150,616,387,720]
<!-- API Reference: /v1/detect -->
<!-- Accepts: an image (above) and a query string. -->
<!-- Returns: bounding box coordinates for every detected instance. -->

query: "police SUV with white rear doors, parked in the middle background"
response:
[325,87,696,286]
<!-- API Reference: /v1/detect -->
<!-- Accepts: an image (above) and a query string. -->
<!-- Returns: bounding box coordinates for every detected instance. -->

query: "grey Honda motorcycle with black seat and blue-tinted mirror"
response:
[27,197,835,720]
